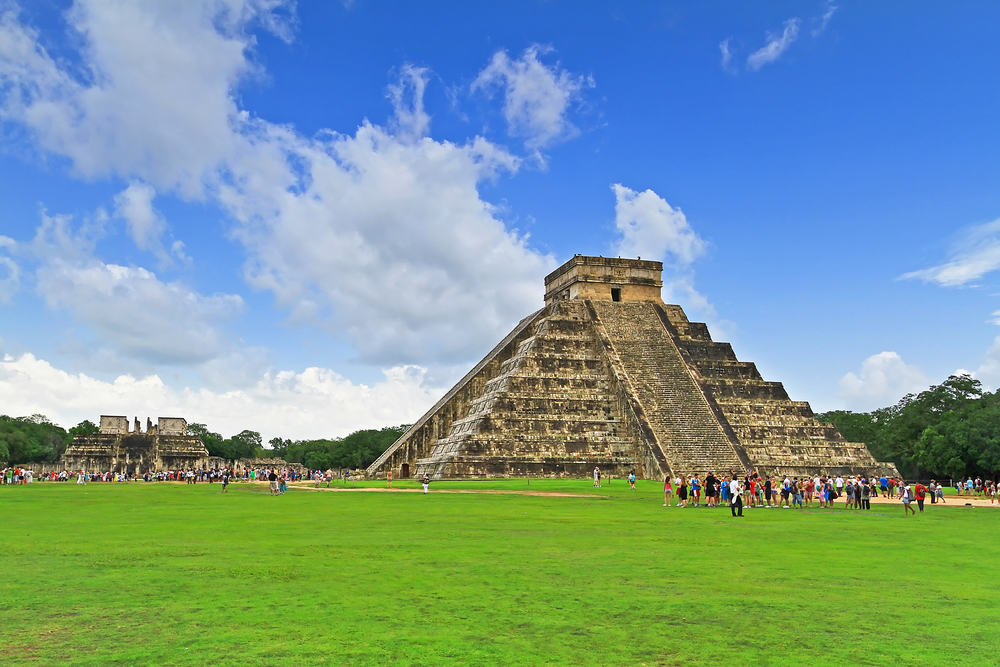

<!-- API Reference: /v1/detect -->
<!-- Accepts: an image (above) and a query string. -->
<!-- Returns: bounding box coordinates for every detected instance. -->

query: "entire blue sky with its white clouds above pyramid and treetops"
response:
[0,0,1000,438]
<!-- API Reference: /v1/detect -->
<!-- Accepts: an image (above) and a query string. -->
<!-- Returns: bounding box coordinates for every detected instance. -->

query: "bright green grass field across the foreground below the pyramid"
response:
[0,480,1000,667]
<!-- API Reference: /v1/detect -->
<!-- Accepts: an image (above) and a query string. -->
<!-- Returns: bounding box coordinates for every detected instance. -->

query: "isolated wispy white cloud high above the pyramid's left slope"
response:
[472,44,594,158]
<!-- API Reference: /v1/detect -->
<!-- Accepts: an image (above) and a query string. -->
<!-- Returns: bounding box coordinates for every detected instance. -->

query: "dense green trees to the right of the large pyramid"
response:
[816,375,1000,479]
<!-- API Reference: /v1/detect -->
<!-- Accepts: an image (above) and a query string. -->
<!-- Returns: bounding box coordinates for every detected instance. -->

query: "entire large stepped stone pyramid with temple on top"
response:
[367,255,898,479]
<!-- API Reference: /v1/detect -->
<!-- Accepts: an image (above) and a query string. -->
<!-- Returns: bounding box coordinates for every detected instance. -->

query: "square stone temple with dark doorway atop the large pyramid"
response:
[545,255,663,304]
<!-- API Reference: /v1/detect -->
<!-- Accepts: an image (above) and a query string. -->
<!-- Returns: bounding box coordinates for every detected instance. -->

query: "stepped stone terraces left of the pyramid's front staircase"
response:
[415,301,637,478]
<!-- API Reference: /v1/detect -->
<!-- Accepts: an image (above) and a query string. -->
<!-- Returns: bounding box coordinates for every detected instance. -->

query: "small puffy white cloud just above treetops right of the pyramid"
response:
[840,352,930,411]
